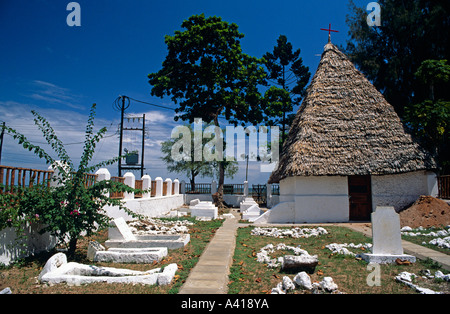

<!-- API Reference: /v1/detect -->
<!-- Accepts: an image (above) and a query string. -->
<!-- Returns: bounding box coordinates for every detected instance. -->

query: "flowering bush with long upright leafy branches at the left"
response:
[0,104,142,254]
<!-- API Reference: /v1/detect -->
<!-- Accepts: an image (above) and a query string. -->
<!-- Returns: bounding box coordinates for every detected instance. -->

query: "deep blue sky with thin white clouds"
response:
[0,0,364,184]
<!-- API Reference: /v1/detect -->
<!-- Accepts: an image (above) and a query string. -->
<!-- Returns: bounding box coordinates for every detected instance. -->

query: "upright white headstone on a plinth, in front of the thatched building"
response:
[362,207,416,264]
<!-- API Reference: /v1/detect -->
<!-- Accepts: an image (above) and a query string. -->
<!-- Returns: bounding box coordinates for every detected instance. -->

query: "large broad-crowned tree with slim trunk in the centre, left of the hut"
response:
[148,14,265,206]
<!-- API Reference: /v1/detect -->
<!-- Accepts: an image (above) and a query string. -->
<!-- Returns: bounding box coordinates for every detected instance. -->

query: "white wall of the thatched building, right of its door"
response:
[372,171,438,211]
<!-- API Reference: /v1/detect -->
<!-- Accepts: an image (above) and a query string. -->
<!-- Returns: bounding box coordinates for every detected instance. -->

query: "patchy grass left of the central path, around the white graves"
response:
[0,218,223,294]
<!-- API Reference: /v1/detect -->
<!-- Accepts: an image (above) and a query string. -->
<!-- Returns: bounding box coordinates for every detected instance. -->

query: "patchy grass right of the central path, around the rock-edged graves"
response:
[228,226,449,294]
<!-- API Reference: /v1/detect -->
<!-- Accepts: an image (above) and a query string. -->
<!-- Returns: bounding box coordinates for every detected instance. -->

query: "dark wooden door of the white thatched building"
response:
[348,176,372,221]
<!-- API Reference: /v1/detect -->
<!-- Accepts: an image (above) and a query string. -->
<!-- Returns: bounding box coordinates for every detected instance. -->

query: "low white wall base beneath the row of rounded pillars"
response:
[104,194,184,221]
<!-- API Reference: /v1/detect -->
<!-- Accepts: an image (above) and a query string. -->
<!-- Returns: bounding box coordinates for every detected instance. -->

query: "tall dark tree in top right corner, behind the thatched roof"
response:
[345,0,450,117]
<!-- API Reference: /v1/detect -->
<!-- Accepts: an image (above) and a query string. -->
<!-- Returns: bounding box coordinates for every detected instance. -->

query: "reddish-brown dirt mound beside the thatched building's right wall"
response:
[400,196,450,228]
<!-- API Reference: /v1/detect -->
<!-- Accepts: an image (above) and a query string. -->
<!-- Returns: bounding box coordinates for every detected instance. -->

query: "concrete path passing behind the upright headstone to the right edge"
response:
[337,223,450,271]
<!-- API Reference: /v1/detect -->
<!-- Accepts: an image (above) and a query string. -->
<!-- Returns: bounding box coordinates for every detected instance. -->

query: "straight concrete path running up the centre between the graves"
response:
[179,211,239,294]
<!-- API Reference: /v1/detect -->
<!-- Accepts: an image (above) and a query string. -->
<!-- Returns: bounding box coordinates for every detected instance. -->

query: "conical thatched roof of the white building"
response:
[269,42,435,183]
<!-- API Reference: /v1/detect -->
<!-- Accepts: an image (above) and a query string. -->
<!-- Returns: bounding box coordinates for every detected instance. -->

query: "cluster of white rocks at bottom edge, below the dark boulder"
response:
[271,271,339,294]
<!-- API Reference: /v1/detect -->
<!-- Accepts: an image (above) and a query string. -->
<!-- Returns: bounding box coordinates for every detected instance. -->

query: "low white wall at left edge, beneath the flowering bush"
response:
[0,224,56,265]
